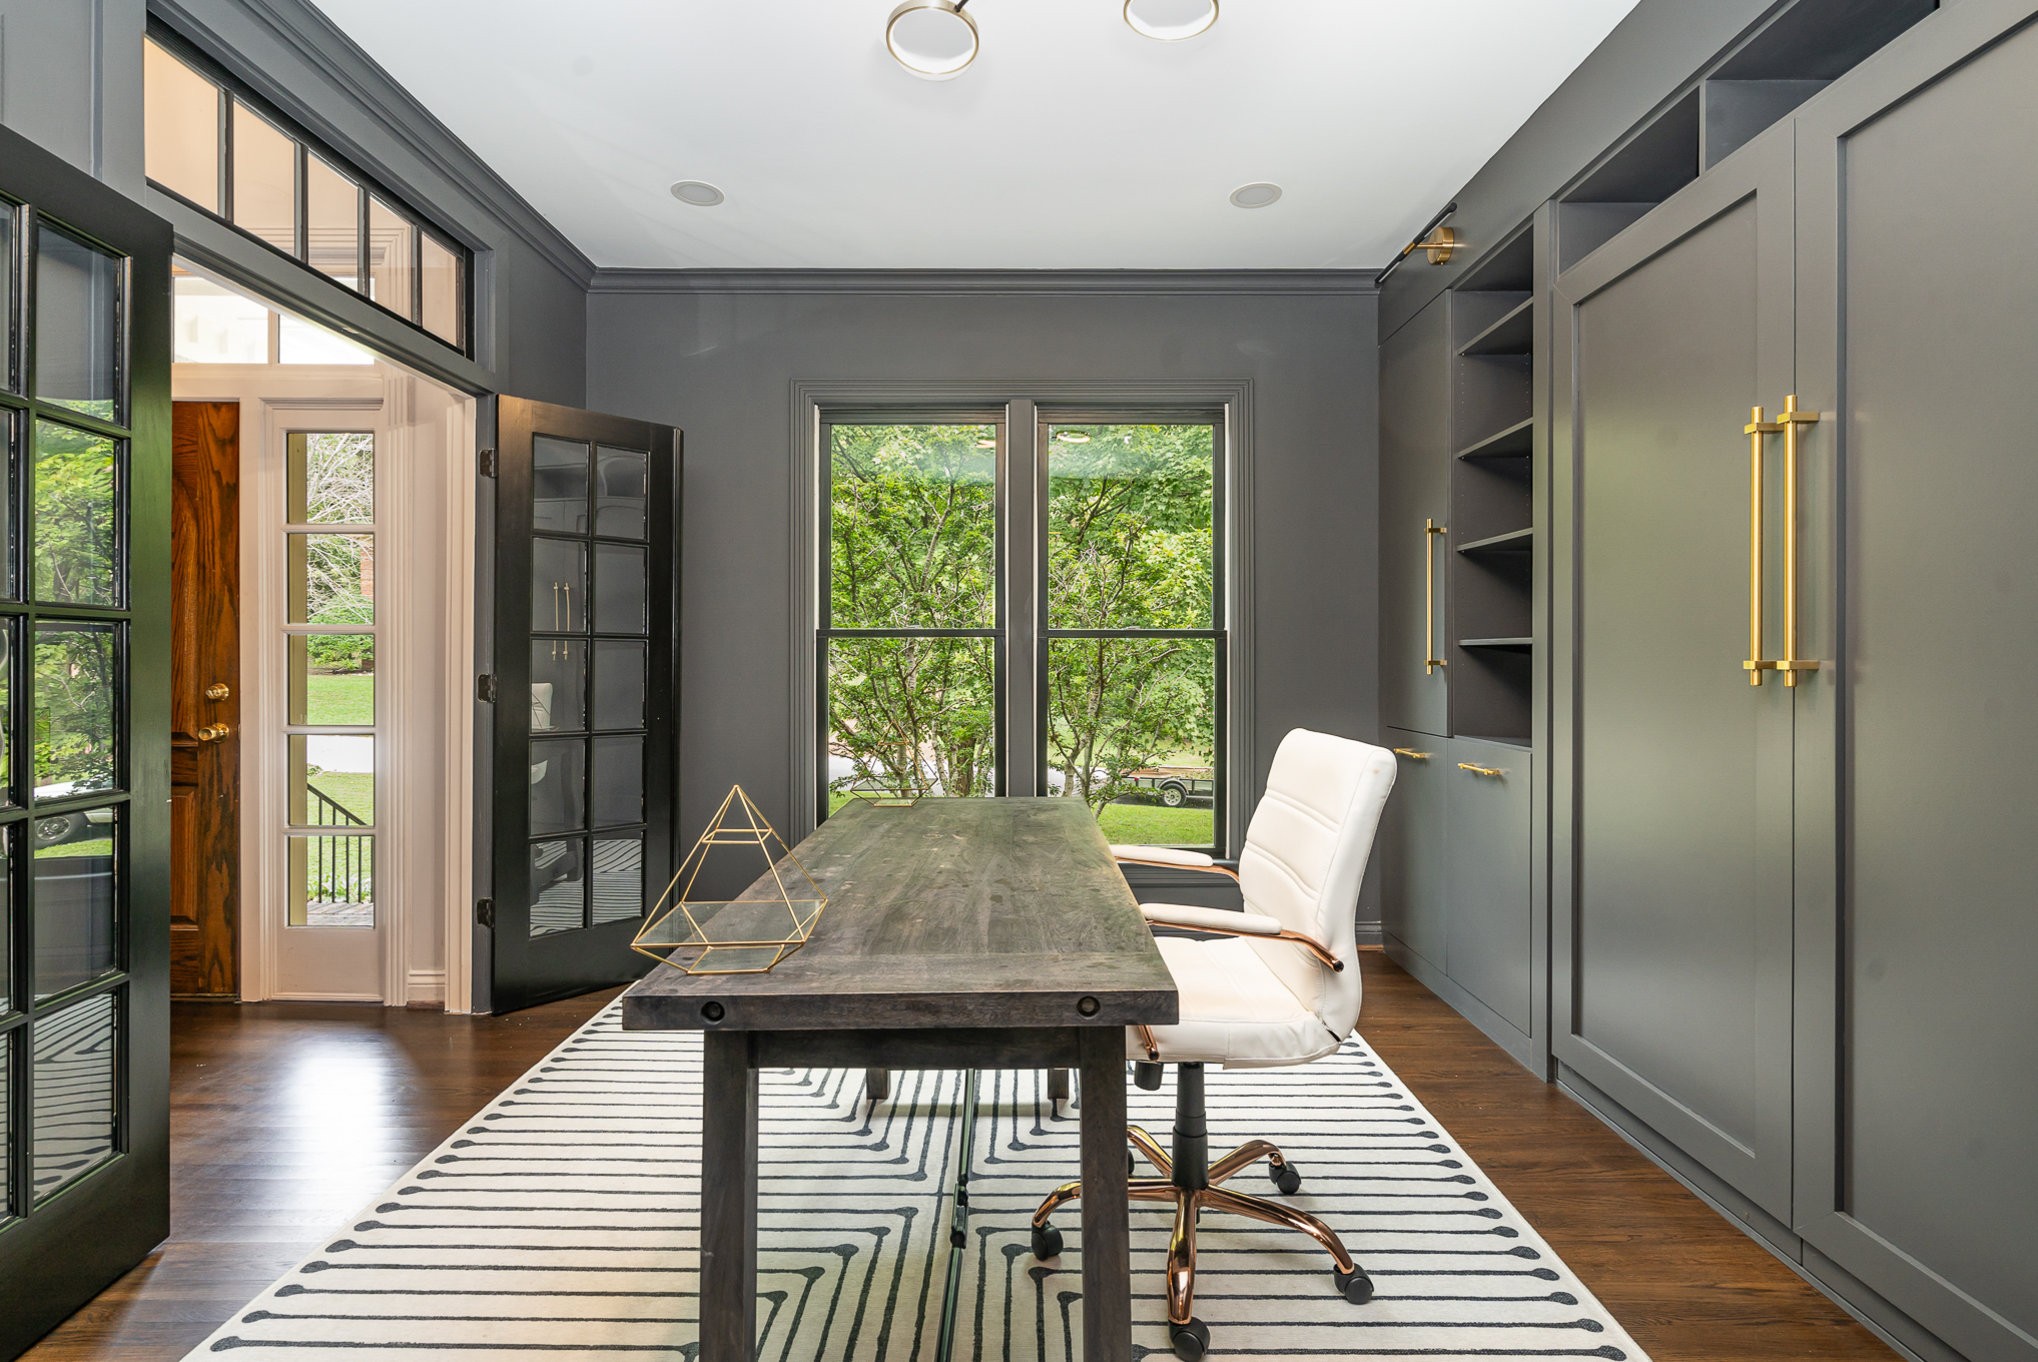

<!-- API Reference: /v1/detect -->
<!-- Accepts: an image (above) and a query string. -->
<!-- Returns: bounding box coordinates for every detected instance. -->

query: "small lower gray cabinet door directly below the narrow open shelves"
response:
[1441,742,1533,1036]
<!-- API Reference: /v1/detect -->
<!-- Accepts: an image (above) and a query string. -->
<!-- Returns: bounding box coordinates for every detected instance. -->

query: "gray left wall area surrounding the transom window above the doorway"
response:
[0,0,593,406]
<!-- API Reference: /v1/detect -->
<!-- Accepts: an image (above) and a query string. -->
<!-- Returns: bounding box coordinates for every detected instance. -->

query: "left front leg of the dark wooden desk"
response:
[701,1032,758,1362]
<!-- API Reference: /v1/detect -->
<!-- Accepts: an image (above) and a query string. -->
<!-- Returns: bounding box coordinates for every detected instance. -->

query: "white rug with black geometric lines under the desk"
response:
[190,1007,1647,1362]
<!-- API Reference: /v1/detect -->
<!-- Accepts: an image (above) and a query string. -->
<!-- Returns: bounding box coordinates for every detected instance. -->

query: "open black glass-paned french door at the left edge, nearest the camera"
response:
[0,130,171,1356]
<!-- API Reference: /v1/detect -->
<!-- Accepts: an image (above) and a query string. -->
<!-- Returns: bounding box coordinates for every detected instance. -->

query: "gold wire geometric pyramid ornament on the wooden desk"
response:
[630,785,827,975]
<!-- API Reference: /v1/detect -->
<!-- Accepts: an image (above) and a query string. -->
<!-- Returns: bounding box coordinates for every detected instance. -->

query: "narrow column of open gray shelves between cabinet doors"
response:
[1445,226,1537,746]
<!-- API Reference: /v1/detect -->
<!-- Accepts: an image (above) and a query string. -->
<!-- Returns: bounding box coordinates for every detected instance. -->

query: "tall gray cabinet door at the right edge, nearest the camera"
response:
[1795,0,2038,1360]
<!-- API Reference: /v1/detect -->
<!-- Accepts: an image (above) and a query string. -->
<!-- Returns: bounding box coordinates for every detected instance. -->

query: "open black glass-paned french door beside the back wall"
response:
[475,398,679,1011]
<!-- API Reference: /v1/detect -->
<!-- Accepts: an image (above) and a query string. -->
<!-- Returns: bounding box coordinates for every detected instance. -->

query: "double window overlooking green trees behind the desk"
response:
[815,412,1227,848]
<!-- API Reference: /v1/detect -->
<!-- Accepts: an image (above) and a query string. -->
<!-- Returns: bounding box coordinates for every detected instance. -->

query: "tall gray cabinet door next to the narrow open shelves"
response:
[1548,128,1793,1219]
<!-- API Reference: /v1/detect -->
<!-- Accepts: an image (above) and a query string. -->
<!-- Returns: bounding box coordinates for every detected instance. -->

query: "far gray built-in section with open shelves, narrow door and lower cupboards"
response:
[1380,213,1549,1068]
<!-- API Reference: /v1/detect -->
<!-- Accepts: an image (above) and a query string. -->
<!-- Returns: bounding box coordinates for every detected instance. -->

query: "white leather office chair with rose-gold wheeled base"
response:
[1033,728,1394,1360]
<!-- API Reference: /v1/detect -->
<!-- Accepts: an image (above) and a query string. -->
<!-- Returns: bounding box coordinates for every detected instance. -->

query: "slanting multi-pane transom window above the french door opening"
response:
[143,35,471,351]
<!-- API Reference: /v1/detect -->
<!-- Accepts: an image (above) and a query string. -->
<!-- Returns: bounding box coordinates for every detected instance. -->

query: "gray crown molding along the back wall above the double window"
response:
[587,269,1378,298]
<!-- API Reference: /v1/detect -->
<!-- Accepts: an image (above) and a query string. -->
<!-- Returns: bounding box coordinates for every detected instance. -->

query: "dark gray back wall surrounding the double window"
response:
[587,275,1378,922]
